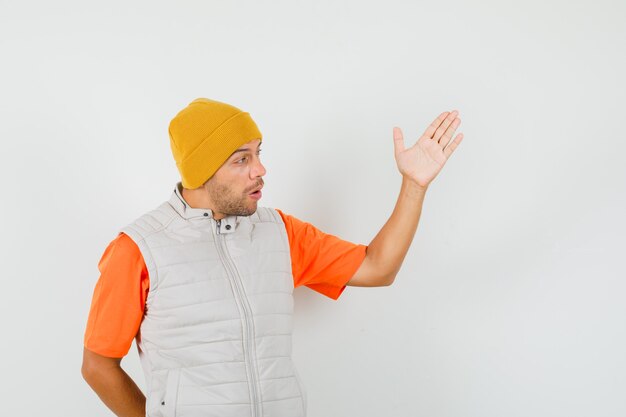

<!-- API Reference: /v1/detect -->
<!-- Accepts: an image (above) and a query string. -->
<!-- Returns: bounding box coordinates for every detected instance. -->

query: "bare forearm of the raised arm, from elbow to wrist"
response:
[366,177,428,284]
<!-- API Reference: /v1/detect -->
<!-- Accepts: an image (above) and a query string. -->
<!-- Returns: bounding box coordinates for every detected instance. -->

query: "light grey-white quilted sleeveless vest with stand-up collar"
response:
[122,183,306,417]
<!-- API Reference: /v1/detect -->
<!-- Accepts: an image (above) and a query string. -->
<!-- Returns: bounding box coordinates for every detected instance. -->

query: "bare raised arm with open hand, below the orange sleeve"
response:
[347,110,463,287]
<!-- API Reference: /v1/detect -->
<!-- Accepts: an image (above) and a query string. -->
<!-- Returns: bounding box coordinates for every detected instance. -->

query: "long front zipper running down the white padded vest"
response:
[216,220,261,417]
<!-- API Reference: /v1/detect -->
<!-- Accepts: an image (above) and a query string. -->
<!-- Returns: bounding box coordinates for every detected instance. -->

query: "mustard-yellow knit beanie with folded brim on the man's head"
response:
[169,98,262,189]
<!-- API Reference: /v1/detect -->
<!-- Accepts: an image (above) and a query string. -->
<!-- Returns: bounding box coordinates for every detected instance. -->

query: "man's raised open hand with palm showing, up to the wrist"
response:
[393,110,463,187]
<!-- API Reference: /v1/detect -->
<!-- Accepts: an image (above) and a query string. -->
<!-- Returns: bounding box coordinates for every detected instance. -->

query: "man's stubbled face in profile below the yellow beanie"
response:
[204,139,266,219]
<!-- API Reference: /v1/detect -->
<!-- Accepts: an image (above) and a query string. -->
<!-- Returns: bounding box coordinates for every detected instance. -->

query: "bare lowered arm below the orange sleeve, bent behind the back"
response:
[81,348,146,417]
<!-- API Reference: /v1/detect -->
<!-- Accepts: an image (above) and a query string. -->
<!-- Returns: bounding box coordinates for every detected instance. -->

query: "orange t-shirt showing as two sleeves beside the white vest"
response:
[84,210,367,358]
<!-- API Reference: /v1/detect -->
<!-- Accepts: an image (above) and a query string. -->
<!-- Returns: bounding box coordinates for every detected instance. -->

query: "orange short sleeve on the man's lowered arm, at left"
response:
[84,233,150,358]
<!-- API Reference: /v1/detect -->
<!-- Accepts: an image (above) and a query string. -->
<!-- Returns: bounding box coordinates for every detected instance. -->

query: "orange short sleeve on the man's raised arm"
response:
[276,209,367,300]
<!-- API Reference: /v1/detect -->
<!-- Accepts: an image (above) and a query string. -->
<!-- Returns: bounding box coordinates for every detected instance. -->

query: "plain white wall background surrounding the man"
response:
[0,0,626,417]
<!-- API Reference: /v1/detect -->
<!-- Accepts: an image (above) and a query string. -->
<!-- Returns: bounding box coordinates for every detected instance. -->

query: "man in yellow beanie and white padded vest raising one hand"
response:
[82,99,463,417]
